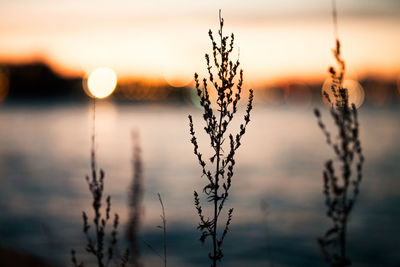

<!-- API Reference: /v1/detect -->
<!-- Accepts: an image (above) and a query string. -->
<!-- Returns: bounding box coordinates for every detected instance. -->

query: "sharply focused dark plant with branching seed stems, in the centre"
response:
[189,10,253,267]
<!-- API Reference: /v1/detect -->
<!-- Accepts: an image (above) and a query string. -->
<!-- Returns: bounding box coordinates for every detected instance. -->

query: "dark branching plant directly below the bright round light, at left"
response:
[71,99,129,267]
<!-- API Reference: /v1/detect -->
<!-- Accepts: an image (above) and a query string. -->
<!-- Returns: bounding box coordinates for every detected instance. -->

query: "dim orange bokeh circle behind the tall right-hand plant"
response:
[321,78,365,108]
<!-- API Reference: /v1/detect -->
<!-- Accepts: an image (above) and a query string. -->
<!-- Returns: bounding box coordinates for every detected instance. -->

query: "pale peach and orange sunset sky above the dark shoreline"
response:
[0,0,400,83]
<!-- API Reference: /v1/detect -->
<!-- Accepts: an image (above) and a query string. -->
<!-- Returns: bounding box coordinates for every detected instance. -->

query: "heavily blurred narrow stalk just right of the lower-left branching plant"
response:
[126,132,143,266]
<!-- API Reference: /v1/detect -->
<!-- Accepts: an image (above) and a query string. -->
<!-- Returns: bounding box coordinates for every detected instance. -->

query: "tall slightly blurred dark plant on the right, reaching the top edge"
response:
[314,2,364,266]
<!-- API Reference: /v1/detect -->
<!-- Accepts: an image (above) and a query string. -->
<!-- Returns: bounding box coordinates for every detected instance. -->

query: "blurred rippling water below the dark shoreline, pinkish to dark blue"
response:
[0,102,400,266]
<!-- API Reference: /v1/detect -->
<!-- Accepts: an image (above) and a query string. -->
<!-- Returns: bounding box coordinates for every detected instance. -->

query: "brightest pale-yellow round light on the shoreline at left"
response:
[87,68,117,98]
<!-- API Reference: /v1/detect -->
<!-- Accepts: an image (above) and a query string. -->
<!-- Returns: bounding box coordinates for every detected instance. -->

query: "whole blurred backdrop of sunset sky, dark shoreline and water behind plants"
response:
[0,0,400,266]
